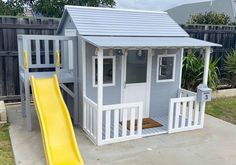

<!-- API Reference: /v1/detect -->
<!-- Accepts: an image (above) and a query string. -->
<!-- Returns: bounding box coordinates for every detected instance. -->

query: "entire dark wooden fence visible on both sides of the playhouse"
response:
[0,17,236,100]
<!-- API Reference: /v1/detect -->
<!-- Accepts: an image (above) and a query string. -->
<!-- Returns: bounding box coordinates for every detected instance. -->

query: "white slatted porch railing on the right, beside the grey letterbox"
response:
[168,89,205,133]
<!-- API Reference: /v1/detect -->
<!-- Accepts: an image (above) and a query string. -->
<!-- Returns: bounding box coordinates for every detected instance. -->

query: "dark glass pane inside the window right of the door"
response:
[158,57,174,80]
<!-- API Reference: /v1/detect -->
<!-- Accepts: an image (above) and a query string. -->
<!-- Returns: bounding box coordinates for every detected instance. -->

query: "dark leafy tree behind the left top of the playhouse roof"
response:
[32,0,115,17]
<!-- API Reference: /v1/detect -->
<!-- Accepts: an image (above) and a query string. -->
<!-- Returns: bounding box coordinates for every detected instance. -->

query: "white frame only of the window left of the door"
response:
[92,56,116,87]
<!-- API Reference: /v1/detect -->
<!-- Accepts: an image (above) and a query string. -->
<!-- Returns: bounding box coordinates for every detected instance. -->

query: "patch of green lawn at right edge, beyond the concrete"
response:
[206,97,236,124]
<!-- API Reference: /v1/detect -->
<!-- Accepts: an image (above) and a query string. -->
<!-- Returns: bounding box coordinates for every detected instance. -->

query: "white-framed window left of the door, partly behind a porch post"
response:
[93,56,115,87]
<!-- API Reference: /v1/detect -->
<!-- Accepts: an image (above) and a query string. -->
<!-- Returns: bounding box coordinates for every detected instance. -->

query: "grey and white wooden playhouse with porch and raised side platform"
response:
[18,6,220,145]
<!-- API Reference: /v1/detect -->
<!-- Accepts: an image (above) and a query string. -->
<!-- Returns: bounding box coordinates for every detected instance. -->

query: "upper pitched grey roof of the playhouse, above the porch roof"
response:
[59,6,189,37]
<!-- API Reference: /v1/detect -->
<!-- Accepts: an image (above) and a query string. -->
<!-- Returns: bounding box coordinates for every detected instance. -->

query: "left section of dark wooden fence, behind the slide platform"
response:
[0,17,59,100]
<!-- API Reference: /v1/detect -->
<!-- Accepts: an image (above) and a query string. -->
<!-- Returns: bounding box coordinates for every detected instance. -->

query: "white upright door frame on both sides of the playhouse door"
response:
[120,49,153,117]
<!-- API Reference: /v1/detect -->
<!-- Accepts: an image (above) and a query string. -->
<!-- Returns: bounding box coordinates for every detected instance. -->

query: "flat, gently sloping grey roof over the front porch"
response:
[82,36,221,48]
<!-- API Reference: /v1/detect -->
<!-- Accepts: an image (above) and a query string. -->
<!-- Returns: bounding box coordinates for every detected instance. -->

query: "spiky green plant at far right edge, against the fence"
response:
[224,50,236,88]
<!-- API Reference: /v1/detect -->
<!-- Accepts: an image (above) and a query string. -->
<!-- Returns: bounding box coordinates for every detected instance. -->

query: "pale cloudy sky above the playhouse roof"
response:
[116,0,210,11]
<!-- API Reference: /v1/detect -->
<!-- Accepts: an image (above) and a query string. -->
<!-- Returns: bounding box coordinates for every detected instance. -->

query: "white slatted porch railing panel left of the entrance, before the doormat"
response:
[102,103,143,144]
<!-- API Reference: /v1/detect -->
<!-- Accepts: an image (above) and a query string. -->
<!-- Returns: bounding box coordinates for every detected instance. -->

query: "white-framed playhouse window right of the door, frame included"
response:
[157,54,176,82]
